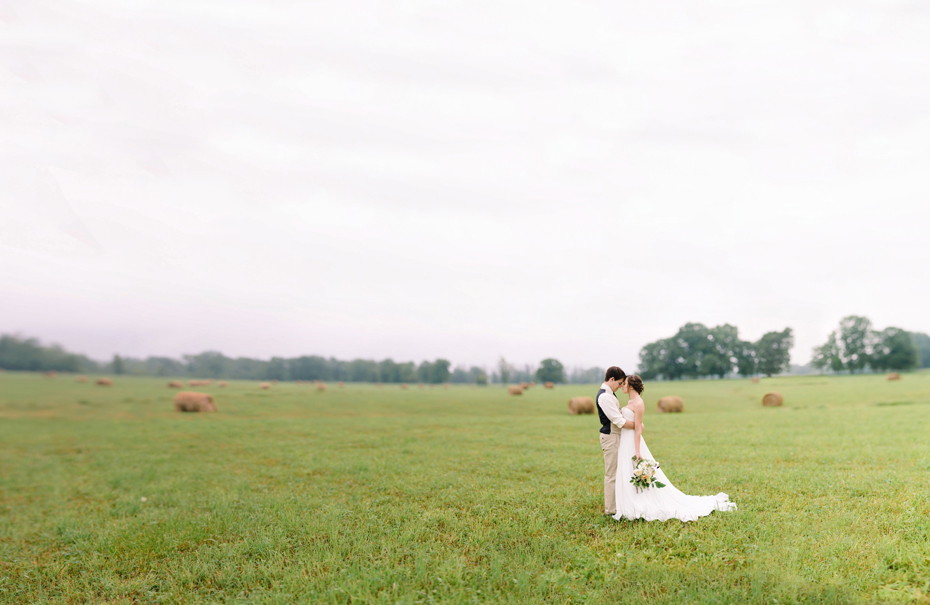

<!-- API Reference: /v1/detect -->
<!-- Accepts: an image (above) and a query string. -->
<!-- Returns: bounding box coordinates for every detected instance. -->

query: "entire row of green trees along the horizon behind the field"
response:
[0,316,930,384]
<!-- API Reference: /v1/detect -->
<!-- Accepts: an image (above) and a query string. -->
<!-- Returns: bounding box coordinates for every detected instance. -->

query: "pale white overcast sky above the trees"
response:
[0,0,930,368]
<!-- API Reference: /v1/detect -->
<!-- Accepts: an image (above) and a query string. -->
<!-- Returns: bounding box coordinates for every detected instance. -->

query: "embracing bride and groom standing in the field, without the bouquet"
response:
[596,366,736,521]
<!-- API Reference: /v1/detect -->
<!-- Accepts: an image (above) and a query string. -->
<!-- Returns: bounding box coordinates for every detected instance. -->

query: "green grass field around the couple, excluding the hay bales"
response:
[0,373,930,604]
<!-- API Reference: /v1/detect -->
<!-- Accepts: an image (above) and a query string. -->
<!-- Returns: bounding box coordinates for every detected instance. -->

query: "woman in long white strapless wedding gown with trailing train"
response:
[614,375,736,521]
